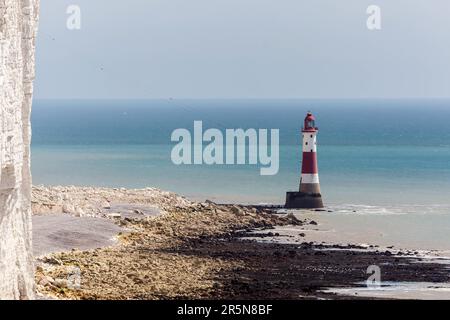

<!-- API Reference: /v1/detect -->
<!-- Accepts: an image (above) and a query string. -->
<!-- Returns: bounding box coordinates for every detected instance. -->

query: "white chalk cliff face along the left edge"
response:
[0,0,39,299]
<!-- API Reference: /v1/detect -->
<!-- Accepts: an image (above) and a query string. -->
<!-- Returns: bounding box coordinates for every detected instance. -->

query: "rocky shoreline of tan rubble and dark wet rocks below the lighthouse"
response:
[33,187,449,299]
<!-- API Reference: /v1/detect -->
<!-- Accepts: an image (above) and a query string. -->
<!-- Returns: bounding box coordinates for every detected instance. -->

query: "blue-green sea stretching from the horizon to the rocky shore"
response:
[32,99,450,249]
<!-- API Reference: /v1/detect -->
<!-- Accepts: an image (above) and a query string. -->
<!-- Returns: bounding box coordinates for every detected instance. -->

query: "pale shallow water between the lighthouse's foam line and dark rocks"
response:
[277,211,450,252]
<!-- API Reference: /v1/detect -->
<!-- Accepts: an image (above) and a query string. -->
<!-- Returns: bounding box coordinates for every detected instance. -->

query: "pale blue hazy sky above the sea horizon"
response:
[35,0,450,98]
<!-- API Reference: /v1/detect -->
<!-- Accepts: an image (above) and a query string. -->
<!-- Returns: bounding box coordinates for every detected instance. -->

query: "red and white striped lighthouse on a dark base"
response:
[285,112,323,209]
